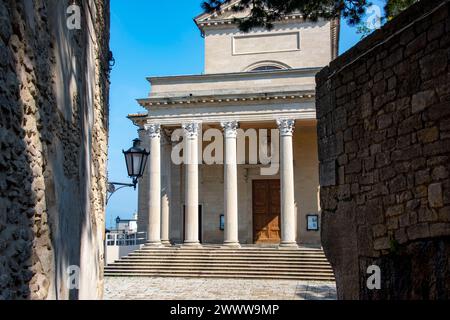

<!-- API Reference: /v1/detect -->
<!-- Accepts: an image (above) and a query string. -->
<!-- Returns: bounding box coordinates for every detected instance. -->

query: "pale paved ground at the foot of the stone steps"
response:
[105,277,336,300]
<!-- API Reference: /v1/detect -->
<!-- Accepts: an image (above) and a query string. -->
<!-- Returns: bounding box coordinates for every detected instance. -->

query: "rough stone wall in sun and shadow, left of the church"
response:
[0,0,109,300]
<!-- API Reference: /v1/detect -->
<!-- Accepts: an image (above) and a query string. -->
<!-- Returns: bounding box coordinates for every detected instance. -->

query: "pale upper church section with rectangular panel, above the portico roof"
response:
[194,0,339,74]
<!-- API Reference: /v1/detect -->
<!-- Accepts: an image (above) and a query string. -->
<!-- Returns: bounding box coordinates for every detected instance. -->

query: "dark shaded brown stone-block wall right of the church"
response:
[317,0,450,299]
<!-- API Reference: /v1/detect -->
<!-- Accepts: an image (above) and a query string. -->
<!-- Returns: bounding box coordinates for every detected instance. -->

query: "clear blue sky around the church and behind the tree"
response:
[106,0,384,227]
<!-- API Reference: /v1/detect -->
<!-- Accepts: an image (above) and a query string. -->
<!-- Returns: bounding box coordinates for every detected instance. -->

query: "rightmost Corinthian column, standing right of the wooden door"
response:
[277,119,297,247]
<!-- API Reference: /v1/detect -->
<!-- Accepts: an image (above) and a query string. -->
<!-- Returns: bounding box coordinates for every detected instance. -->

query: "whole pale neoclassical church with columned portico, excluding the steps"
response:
[129,1,339,248]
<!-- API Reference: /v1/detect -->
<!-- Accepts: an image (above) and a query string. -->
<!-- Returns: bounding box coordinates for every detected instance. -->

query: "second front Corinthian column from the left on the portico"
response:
[183,123,200,246]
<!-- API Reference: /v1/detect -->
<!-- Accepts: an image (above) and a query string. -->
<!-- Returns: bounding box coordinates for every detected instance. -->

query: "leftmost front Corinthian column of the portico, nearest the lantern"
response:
[145,124,161,246]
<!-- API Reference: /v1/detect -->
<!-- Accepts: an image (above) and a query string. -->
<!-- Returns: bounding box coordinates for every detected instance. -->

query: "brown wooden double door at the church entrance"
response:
[253,180,281,244]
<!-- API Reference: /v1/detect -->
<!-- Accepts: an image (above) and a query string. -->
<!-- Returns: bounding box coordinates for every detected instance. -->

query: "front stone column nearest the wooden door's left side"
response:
[222,121,240,247]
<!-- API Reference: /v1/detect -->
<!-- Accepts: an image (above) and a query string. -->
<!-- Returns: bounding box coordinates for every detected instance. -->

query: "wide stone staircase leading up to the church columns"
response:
[105,246,334,281]
